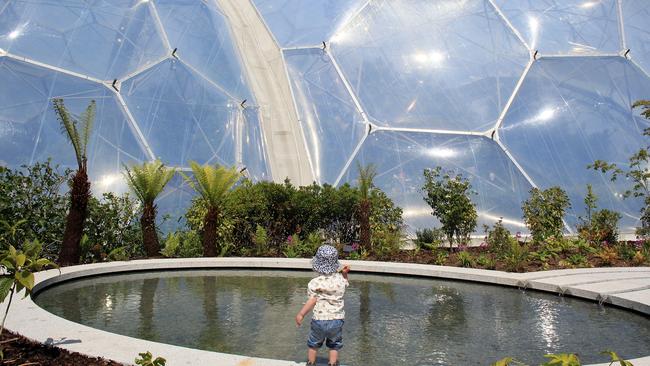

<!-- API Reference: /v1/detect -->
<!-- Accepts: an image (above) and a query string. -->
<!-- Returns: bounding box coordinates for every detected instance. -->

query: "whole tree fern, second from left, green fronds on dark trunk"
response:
[124,160,176,257]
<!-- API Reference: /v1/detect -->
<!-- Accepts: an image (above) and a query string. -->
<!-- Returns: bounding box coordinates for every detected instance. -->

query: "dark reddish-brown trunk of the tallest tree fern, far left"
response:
[59,166,90,266]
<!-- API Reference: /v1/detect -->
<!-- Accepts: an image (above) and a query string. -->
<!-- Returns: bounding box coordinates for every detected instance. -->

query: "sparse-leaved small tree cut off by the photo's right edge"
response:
[587,100,650,236]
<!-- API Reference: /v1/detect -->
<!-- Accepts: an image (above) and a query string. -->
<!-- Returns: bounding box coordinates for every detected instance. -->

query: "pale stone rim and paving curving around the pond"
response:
[3,258,650,366]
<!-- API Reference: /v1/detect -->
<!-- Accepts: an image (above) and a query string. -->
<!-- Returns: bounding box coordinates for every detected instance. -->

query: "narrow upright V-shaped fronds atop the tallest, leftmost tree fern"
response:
[52,98,96,169]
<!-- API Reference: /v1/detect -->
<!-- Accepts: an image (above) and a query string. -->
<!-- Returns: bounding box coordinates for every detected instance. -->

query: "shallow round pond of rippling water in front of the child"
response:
[35,270,650,365]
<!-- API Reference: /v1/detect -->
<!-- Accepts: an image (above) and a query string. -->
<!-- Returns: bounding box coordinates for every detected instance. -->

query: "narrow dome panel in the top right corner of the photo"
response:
[622,0,650,75]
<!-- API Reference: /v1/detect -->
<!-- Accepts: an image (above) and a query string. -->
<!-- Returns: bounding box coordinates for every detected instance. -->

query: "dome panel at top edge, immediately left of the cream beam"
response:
[155,0,252,102]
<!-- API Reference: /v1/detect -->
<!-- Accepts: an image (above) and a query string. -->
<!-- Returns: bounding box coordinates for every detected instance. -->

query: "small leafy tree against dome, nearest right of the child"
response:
[423,167,478,248]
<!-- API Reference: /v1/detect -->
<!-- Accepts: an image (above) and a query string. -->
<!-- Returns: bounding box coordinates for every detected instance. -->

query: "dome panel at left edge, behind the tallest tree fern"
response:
[0,58,145,193]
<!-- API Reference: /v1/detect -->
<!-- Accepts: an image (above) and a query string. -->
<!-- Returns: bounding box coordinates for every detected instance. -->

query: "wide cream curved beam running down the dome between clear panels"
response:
[215,0,314,185]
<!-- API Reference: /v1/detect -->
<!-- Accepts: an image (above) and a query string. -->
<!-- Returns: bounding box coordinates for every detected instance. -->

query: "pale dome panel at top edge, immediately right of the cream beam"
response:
[253,0,367,47]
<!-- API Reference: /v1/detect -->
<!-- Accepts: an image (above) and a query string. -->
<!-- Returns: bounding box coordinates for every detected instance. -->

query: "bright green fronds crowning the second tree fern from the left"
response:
[124,160,176,204]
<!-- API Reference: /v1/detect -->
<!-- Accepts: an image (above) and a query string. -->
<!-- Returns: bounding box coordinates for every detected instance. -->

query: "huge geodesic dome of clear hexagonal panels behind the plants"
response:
[0,0,650,232]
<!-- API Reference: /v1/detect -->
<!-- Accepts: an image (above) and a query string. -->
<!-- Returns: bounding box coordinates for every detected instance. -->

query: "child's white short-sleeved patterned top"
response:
[307,272,348,320]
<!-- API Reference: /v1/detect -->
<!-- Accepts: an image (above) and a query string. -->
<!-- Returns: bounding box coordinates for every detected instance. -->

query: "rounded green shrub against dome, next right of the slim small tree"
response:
[522,187,571,242]
